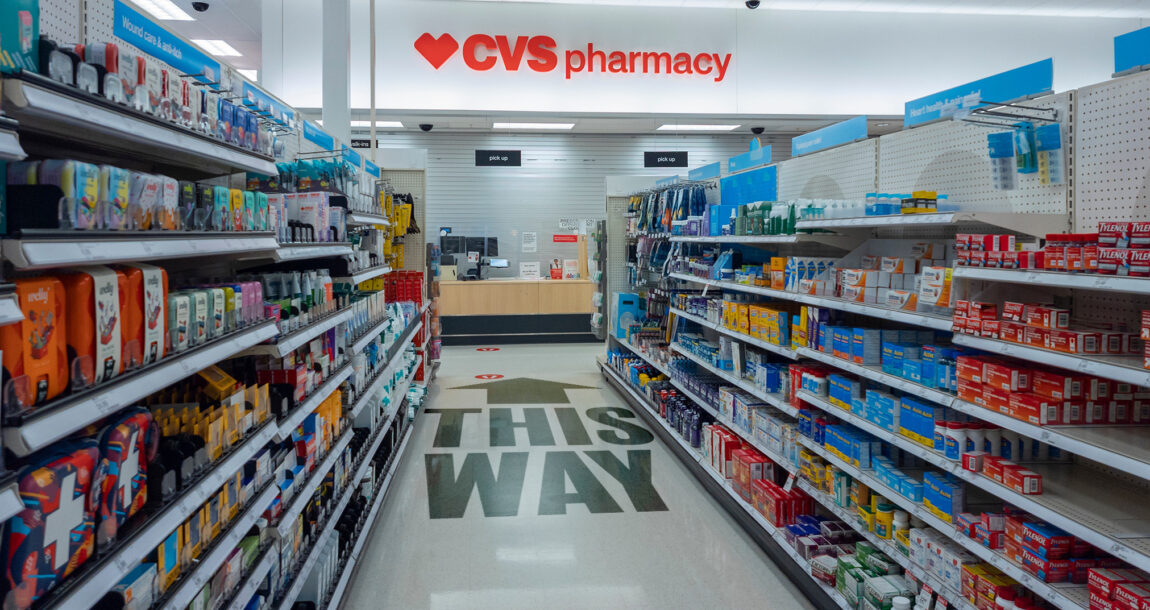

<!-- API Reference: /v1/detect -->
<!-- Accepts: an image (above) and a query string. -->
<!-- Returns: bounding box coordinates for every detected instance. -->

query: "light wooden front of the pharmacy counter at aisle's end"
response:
[439,280,596,315]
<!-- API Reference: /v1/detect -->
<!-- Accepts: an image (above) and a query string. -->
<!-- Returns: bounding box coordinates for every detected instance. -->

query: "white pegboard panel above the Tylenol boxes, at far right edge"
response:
[1074,68,1150,232]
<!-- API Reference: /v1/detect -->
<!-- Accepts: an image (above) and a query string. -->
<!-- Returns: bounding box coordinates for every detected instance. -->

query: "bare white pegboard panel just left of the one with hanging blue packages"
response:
[779,139,877,201]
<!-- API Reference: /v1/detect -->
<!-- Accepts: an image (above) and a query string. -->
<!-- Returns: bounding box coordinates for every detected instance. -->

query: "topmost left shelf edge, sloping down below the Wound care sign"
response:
[2,73,276,176]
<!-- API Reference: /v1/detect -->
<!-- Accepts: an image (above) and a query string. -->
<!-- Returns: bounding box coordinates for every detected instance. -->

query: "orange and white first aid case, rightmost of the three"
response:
[116,264,168,365]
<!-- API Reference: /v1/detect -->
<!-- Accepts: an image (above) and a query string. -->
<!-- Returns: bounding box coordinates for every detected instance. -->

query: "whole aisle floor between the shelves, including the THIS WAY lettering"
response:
[344,345,811,610]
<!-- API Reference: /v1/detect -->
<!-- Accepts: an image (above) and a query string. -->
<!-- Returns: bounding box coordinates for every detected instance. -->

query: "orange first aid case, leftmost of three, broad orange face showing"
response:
[0,277,68,406]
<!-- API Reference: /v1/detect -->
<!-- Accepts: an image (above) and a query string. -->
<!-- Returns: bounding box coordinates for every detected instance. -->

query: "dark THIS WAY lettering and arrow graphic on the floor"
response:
[424,378,668,519]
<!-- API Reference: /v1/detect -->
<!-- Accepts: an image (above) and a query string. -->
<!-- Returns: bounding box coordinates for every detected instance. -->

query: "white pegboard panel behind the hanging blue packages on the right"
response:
[877,93,1073,214]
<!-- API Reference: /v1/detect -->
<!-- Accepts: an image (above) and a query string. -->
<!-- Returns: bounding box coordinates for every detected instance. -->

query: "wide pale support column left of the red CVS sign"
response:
[323,0,352,145]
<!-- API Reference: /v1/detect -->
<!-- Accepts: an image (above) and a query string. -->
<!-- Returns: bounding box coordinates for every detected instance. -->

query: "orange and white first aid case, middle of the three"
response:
[60,266,130,386]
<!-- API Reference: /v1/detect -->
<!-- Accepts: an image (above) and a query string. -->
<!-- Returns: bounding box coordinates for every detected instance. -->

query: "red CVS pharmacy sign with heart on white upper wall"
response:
[415,32,731,83]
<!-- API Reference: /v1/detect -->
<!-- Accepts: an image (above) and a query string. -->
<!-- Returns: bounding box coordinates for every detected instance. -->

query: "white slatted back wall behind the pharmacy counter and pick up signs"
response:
[380,132,754,276]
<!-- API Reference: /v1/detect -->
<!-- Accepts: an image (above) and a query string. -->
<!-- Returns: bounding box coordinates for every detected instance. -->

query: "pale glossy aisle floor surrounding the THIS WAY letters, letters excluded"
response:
[344,344,811,610]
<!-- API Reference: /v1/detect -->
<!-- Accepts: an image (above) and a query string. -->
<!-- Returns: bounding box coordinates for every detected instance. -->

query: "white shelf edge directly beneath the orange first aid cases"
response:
[2,320,276,457]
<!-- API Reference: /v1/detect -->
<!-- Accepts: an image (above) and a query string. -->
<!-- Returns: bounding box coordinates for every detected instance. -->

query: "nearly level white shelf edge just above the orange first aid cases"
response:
[0,230,280,269]
